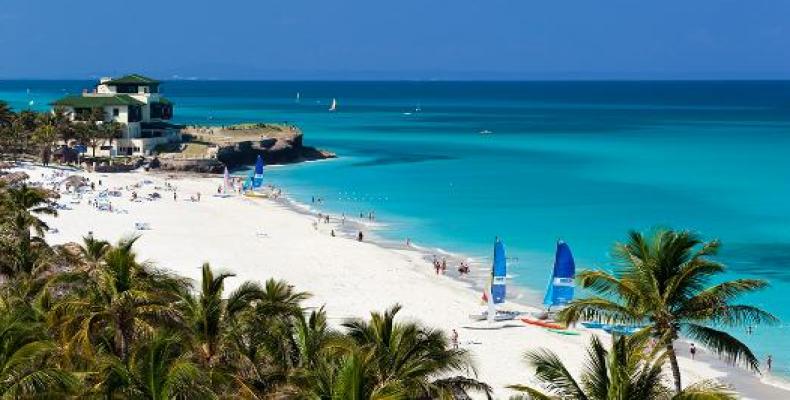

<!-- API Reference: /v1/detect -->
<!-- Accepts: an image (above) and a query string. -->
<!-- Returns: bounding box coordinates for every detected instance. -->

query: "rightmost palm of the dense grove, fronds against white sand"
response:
[341,305,491,399]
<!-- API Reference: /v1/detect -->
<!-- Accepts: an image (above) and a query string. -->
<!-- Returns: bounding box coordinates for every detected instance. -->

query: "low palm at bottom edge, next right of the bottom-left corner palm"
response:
[91,331,218,400]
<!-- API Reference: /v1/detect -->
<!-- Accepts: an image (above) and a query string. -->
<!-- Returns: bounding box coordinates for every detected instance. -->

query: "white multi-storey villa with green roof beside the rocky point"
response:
[52,74,181,155]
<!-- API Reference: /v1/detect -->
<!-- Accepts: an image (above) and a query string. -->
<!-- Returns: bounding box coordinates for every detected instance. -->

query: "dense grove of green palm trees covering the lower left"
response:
[0,176,491,400]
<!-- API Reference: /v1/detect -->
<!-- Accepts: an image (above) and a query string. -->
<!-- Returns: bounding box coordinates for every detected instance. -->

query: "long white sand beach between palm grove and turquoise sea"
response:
[17,167,790,400]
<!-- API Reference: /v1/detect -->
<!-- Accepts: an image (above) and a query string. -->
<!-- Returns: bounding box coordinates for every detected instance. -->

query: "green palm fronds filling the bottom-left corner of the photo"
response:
[0,297,79,399]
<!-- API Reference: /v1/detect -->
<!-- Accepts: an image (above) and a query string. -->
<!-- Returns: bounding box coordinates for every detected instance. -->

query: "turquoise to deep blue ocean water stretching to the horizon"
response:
[0,81,790,375]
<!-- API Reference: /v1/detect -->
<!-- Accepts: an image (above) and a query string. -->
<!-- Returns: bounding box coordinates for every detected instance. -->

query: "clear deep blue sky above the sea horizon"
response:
[0,0,790,80]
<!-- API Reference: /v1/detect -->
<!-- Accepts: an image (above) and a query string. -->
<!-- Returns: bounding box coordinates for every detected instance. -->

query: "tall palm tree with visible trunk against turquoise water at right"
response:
[559,230,777,392]
